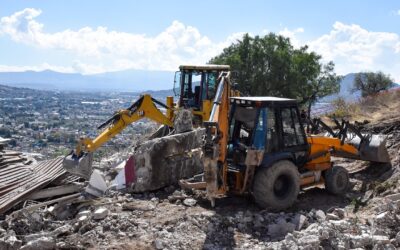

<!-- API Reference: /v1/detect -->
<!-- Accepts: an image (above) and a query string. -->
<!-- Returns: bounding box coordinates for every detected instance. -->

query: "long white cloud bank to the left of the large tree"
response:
[0,8,242,73]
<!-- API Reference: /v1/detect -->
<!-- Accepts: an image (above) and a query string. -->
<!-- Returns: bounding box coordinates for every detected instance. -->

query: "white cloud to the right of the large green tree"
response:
[307,22,400,81]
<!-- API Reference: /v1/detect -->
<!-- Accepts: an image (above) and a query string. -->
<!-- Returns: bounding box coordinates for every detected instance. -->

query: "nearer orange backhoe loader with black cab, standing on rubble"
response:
[180,73,390,210]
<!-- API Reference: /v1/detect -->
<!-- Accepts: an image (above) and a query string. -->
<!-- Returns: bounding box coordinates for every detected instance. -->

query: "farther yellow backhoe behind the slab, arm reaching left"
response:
[63,65,236,178]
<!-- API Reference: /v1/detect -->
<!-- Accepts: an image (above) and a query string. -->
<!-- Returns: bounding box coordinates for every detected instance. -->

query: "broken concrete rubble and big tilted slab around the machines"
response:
[0,116,400,249]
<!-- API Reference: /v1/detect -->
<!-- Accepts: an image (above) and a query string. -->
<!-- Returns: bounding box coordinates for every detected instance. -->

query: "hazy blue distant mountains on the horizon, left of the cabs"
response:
[0,70,174,92]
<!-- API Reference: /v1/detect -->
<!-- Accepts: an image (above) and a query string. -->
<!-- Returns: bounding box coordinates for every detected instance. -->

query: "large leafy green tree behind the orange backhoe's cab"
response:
[210,33,341,116]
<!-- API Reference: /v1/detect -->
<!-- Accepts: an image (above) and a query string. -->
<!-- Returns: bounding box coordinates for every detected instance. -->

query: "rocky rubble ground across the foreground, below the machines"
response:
[0,183,400,249]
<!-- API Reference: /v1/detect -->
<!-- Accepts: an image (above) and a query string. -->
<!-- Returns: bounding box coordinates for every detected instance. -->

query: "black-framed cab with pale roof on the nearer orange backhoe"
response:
[228,97,308,168]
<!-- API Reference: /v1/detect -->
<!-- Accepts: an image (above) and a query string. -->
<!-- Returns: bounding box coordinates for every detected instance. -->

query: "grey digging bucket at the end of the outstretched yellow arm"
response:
[63,152,93,180]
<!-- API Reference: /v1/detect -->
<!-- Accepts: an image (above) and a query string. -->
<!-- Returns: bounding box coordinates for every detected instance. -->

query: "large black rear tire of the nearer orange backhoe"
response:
[253,160,300,210]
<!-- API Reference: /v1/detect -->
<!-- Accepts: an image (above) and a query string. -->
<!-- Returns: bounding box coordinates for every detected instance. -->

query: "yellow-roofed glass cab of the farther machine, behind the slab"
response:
[174,65,230,111]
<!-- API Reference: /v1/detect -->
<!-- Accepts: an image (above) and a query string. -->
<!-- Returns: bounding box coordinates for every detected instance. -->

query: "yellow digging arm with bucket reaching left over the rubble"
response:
[63,94,173,178]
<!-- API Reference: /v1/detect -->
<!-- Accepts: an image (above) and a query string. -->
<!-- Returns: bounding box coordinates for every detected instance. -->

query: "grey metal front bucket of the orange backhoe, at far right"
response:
[348,135,390,163]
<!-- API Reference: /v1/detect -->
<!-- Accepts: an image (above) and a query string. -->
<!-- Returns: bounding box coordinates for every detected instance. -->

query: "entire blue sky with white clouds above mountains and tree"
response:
[0,0,400,82]
